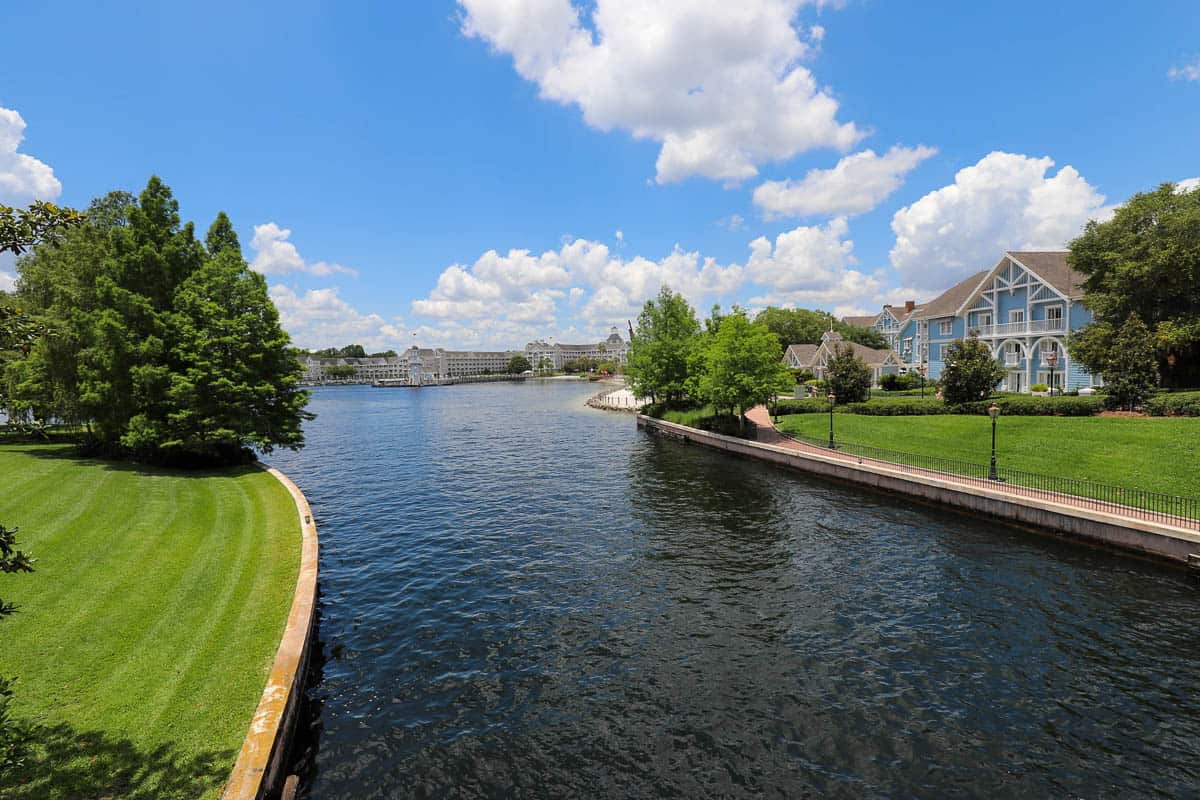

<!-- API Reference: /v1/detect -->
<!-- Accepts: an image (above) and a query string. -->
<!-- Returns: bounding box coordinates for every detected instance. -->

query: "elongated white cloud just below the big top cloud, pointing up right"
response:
[754,145,937,219]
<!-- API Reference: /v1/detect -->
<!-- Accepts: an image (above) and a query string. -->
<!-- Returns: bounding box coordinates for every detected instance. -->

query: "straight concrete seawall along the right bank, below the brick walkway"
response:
[637,414,1200,565]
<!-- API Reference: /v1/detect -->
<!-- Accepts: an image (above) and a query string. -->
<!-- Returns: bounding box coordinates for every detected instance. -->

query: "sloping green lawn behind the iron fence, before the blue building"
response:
[779,414,1200,498]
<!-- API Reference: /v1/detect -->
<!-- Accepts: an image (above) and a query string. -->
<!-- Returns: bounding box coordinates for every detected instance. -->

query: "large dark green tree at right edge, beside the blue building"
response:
[1068,184,1200,386]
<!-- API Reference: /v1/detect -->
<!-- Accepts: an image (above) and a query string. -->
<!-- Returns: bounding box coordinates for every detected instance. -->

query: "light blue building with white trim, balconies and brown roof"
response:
[846,251,1100,392]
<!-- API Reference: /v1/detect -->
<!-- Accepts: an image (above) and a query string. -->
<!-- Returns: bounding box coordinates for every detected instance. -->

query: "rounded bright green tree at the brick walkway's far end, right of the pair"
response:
[692,306,792,414]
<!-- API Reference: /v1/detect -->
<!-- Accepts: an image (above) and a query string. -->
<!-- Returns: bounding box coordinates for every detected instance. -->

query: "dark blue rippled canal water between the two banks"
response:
[269,381,1200,799]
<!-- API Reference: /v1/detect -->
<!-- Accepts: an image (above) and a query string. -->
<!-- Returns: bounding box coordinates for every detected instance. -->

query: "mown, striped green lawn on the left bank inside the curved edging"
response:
[0,444,300,798]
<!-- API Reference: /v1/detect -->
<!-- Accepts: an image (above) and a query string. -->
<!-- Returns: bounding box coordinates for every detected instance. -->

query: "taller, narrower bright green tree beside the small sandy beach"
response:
[626,287,700,402]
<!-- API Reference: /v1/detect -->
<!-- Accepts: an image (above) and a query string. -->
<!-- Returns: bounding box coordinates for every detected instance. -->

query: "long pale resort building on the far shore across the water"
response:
[300,327,629,386]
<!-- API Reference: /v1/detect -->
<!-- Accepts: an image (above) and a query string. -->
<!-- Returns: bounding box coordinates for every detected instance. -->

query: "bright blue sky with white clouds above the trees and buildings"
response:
[0,0,1200,348]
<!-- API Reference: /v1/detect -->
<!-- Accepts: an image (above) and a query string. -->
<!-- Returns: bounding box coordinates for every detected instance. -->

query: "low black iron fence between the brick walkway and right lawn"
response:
[780,432,1200,530]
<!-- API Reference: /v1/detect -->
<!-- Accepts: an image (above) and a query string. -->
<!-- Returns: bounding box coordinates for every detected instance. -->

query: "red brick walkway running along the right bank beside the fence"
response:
[746,405,1200,535]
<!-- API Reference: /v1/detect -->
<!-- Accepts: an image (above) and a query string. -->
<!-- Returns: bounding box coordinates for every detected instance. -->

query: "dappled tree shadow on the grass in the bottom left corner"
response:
[0,723,235,800]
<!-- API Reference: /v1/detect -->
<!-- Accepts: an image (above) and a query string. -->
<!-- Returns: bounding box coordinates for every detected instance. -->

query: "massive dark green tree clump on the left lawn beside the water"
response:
[5,176,307,464]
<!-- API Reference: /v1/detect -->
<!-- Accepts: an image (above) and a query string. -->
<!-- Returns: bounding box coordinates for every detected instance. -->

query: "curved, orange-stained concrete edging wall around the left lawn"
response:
[221,467,318,800]
